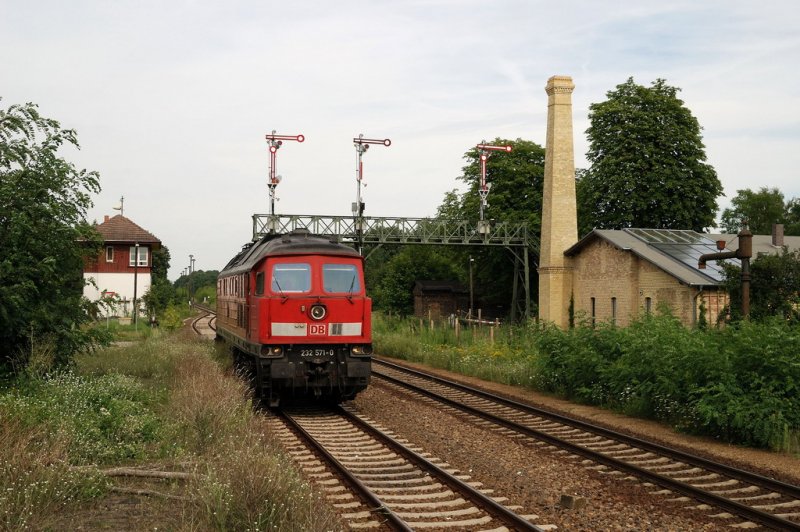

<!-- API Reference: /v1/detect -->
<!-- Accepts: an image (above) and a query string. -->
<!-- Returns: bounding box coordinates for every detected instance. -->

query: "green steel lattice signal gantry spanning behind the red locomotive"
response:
[253,214,539,320]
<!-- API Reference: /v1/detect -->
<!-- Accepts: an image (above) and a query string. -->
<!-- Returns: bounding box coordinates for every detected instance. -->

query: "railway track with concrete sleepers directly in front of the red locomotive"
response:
[268,407,555,530]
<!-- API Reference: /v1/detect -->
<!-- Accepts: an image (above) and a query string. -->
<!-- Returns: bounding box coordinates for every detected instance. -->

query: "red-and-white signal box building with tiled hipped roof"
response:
[83,214,161,316]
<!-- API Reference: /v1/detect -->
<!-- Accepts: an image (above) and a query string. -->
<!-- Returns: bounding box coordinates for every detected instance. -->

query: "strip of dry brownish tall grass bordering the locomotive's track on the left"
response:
[168,353,340,530]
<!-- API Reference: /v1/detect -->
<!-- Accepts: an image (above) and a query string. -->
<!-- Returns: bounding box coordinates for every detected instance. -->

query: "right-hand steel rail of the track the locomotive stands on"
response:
[338,406,543,532]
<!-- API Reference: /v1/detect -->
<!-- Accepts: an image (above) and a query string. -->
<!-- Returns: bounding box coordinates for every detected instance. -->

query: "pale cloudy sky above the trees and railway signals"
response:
[0,0,800,280]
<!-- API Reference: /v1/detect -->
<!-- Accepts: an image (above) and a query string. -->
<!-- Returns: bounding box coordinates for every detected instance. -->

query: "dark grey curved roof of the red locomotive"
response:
[220,230,361,276]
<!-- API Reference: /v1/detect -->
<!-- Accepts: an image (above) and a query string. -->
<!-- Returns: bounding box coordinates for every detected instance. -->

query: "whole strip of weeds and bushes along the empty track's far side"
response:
[374,311,800,453]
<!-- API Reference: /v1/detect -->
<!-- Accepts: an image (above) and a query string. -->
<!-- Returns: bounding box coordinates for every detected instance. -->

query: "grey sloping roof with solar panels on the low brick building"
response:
[564,229,738,286]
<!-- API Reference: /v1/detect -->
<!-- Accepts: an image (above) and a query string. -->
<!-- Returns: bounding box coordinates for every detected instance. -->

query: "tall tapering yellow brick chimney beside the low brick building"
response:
[539,76,578,328]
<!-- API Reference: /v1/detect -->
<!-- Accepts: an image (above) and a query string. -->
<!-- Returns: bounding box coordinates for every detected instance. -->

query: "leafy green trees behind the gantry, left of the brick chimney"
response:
[366,138,544,316]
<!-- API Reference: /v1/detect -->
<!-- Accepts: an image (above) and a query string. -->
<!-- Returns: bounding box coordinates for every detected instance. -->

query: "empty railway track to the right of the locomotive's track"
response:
[373,359,800,530]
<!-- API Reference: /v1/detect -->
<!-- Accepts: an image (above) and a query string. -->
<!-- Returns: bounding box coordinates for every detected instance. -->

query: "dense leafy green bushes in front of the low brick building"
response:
[536,314,800,451]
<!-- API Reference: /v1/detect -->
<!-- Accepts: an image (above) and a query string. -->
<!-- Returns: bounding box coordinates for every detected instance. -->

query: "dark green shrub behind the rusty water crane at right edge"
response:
[725,249,800,323]
